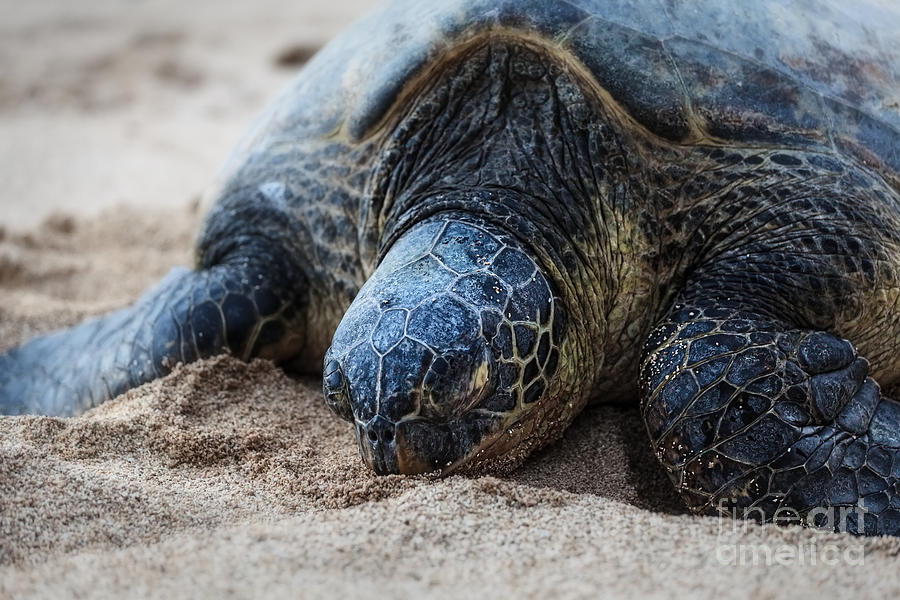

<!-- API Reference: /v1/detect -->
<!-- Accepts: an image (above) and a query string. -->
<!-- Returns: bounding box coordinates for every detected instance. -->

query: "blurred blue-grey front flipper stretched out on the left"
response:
[0,260,304,415]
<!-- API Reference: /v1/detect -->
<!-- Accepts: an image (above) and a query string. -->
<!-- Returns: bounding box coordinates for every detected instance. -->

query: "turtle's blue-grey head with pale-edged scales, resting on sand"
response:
[324,219,562,474]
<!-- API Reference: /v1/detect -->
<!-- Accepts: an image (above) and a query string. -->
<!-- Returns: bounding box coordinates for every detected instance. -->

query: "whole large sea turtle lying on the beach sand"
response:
[0,0,900,534]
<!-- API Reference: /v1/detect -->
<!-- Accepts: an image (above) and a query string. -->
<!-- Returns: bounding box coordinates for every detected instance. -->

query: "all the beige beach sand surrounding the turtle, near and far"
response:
[0,0,900,600]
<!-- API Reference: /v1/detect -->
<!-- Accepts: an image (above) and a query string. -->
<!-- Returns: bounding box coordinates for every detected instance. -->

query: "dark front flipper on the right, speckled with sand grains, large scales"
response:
[640,299,900,535]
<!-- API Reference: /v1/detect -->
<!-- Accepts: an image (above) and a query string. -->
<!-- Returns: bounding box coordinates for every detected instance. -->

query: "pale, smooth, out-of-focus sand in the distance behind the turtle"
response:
[0,0,374,227]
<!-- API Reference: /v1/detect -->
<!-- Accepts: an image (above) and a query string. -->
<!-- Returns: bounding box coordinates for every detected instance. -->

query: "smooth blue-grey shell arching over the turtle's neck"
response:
[234,0,900,184]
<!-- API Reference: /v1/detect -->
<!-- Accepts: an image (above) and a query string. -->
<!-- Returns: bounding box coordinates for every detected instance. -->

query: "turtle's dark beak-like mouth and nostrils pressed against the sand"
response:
[355,411,506,476]
